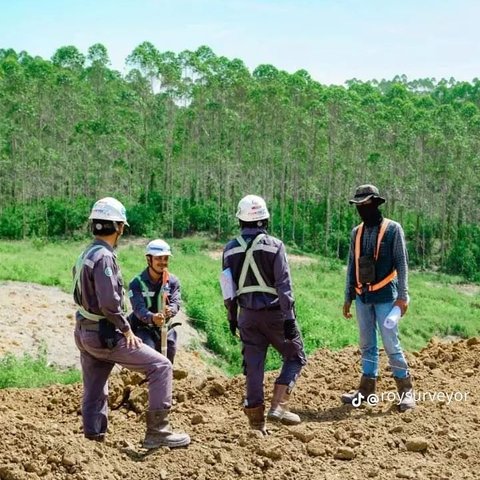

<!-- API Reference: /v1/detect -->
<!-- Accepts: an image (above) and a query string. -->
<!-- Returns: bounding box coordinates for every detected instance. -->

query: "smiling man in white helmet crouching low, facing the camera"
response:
[128,239,181,363]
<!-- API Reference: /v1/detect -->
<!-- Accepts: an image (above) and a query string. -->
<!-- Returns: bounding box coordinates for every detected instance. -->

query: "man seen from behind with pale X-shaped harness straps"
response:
[223,195,306,434]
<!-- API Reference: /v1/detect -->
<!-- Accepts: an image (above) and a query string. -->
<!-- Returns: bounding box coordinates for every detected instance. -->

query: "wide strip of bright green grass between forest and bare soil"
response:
[0,237,480,374]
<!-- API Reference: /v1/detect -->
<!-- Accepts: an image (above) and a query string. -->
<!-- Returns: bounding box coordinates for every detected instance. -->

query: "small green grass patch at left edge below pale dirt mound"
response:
[0,349,81,388]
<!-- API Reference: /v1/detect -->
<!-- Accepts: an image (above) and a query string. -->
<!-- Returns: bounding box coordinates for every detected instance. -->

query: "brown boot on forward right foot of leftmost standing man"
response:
[143,410,190,449]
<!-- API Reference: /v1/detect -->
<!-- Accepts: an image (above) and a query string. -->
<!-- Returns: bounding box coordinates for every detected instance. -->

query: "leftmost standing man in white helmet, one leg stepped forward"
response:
[73,197,190,448]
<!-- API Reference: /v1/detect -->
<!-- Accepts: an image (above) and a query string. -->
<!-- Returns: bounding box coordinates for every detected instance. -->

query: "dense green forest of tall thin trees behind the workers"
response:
[0,42,480,281]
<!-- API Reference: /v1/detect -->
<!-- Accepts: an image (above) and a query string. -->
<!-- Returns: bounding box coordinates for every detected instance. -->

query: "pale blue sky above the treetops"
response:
[0,0,480,84]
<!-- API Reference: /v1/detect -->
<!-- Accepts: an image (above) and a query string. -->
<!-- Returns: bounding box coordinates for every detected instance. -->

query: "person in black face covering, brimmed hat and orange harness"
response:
[342,185,415,411]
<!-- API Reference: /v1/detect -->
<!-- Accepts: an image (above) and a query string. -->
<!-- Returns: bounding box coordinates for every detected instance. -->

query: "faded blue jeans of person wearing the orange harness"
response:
[355,298,409,378]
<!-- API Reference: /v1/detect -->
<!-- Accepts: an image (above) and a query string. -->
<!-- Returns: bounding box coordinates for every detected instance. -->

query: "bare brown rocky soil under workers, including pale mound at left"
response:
[0,283,480,480]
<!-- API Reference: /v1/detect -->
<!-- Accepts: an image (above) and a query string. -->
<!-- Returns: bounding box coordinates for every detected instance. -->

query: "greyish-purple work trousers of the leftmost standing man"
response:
[74,322,173,436]
